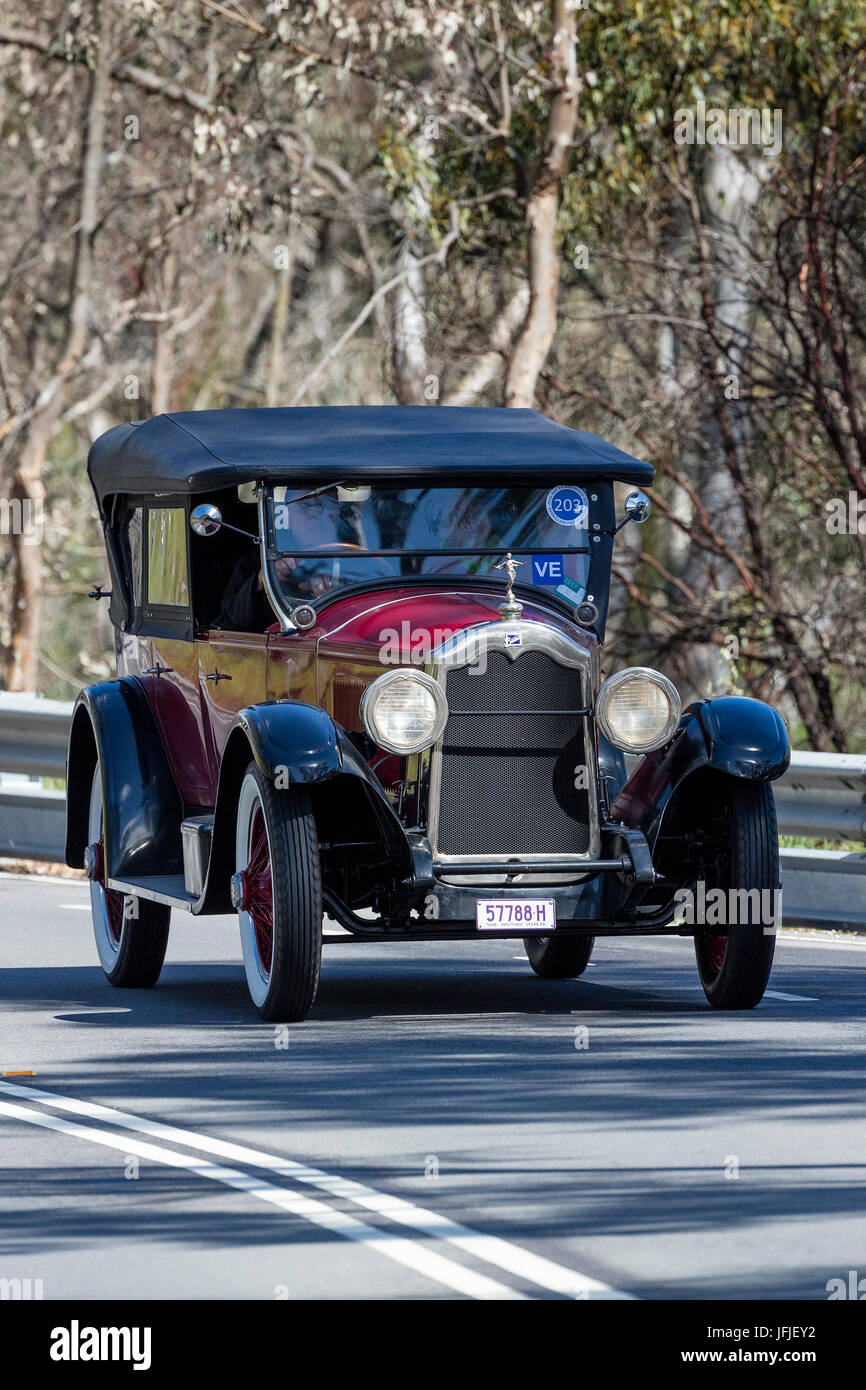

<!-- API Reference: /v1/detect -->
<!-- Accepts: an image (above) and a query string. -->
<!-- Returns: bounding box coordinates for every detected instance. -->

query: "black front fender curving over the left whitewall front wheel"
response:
[195,701,411,913]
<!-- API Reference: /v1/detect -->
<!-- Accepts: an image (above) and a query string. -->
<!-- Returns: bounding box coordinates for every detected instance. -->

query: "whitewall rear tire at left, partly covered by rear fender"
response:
[88,763,171,990]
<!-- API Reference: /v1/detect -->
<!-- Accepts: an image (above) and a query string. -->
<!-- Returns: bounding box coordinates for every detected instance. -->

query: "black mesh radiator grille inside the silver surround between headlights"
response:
[436,652,589,856]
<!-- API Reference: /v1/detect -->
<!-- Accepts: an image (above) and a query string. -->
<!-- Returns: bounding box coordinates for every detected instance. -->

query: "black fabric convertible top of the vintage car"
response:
[88,406,655,509]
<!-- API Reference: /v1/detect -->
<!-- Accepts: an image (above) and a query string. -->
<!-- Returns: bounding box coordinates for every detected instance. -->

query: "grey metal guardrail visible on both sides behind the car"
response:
[0,694,866,930]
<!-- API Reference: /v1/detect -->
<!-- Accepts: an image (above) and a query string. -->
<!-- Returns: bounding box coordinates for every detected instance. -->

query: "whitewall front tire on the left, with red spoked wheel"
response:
[232,763,322,1023]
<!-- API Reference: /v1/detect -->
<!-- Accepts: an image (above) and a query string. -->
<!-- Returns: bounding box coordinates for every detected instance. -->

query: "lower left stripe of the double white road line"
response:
[0,1087,525,1300]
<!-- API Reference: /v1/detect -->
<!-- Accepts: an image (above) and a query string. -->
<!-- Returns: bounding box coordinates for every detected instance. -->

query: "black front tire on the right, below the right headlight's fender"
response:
[695,781,781,1009]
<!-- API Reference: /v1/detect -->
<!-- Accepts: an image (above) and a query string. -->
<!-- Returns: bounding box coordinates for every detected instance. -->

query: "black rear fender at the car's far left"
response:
[65,676,183,878]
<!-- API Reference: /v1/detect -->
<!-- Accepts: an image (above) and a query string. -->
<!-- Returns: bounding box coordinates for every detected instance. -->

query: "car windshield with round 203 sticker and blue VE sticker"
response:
[267,482,594,607]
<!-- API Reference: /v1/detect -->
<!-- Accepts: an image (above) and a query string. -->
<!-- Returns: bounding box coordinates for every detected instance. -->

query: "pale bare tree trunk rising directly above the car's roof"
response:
[505,0,581,407]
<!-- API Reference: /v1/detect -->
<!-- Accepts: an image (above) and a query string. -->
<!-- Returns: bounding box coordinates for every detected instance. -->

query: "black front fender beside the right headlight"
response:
[610,695,791,848]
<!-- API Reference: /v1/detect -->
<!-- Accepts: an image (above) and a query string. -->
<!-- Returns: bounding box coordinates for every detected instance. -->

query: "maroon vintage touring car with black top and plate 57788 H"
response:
[67,406,790,1020]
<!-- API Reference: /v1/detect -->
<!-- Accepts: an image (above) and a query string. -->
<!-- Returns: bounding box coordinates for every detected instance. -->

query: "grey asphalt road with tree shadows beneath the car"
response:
[0,874,866,1300]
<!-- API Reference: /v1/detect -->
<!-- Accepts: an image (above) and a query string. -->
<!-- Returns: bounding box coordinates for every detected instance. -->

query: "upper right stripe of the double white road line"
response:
[0,1081,631,1300]
